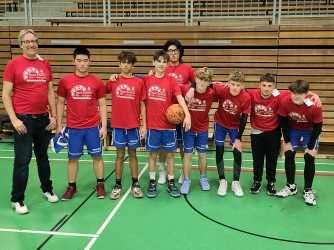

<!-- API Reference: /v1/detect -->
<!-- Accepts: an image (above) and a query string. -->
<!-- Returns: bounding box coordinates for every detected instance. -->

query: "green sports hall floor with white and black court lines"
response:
[0,143,334,250]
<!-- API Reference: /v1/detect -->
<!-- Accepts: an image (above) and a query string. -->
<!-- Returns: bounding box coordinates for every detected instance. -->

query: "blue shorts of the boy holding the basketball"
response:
[146,129,176,152]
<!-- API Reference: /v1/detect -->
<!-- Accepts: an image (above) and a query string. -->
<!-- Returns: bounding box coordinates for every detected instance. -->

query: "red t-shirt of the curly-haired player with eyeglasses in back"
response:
[166,63,195,84]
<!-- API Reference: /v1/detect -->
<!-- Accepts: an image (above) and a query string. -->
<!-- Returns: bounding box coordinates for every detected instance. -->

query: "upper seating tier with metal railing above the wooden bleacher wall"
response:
[0,0,334,25]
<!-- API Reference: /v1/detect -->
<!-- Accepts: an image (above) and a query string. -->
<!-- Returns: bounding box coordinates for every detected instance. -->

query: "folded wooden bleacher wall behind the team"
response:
[0,26,334,152]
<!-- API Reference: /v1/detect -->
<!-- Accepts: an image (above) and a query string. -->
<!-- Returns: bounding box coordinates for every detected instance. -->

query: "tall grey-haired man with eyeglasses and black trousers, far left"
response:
[2,29,58,214]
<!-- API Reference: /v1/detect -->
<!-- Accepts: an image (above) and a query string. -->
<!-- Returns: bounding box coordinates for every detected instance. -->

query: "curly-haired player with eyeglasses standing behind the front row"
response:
[158,39,195,184]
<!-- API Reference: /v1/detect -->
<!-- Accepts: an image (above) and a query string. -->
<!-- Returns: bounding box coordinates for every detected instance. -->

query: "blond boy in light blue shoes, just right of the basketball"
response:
[180,67,214,194]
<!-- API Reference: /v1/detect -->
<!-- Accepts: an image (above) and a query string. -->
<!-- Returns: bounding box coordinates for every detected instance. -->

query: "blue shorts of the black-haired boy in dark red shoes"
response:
[68,127,102,159]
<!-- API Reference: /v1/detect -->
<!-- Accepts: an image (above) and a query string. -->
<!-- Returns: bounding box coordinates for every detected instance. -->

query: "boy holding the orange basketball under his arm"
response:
[145,50,191,198]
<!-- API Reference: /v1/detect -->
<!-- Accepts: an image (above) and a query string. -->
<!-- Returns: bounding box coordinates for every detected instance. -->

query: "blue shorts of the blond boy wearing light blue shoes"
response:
[183,130,208,153]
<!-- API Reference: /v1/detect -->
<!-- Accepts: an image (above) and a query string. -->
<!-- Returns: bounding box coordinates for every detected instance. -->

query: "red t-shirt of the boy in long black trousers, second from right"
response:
[247,89,289,132]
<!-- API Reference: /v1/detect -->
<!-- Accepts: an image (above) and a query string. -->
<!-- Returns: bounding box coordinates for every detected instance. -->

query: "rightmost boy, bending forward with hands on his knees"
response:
[277,80,323,206]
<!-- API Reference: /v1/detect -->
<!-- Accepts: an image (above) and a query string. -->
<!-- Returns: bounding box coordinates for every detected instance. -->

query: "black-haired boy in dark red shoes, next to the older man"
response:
[57,47,107,200]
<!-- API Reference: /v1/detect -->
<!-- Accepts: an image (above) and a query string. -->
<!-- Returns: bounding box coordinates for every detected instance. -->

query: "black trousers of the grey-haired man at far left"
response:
[11,114,52,202]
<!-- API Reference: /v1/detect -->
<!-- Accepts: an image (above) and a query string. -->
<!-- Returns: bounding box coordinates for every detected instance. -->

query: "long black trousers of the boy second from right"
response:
[251,129,281,183]
